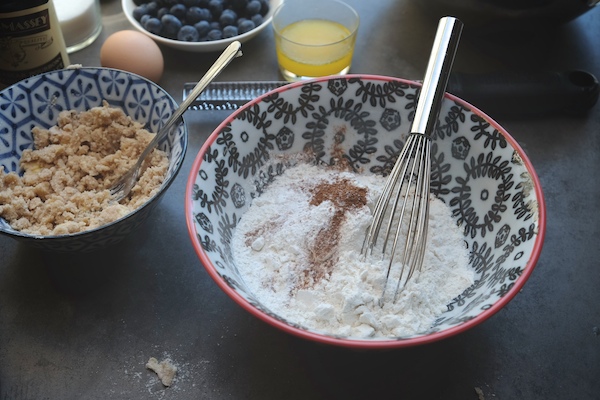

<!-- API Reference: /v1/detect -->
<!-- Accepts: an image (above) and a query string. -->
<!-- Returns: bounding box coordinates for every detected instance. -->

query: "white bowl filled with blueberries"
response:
[122,0,283,52]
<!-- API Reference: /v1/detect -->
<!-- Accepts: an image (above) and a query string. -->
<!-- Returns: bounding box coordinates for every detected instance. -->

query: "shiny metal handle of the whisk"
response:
[411,17,463,136]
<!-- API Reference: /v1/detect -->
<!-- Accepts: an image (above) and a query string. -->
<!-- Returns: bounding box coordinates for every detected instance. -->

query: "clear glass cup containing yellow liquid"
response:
[273,0,359,82]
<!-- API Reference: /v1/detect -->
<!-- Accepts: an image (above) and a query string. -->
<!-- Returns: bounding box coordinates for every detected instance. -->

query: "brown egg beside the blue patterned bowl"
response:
[100,30,164,82]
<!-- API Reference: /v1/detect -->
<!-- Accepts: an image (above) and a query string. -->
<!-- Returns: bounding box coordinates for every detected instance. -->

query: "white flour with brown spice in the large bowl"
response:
[232,163,474,339]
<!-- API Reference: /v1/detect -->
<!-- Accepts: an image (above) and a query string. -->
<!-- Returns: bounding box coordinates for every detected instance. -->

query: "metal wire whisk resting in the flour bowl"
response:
[361,17,463,302]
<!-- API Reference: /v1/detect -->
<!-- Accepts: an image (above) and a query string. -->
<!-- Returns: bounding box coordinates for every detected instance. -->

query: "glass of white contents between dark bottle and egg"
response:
[53,0,102,53]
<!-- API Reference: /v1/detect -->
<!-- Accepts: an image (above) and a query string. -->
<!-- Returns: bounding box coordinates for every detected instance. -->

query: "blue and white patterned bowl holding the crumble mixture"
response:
[0,68,188,252]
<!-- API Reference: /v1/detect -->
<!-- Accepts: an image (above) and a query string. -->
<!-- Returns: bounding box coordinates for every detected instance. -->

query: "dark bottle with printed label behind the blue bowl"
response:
[0,0,69,87]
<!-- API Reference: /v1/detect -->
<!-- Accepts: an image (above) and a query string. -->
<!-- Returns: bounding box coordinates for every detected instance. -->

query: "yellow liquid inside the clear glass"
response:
[276,19,355,77]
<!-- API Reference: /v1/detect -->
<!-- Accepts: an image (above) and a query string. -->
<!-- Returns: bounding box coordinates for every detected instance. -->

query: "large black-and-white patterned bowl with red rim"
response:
[185,75,546,349]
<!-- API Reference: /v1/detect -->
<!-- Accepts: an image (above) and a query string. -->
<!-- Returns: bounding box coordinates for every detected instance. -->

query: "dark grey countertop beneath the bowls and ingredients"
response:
[0,0,600,400]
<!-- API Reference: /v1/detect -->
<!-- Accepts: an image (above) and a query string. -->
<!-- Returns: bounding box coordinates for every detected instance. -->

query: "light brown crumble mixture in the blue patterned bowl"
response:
[0,102,169,236]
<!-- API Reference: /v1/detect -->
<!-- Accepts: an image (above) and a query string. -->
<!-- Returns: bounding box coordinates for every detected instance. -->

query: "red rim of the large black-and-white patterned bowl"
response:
[185,74,546,349]
